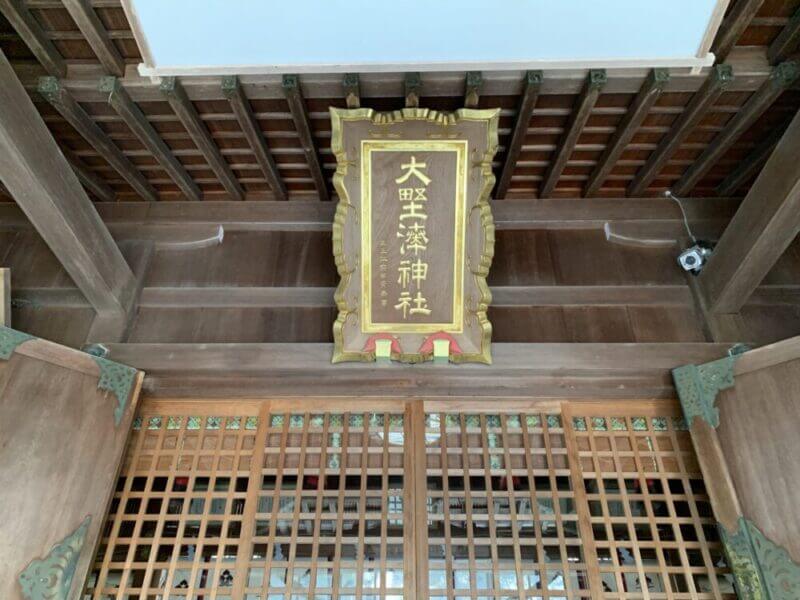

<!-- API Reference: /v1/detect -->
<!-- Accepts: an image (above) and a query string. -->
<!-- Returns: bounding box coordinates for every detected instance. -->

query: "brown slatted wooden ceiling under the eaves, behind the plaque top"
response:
[0,0,800,200]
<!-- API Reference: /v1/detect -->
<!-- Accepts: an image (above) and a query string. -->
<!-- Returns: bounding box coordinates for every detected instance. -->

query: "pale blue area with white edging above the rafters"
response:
[132,0,716,67]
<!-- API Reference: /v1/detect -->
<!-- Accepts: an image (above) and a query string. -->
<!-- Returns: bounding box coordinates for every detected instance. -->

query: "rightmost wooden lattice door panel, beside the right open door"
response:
[569,404,736,600]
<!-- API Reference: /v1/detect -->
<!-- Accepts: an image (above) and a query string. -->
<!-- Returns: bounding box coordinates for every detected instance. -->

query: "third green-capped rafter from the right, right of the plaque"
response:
[585,69,669,198]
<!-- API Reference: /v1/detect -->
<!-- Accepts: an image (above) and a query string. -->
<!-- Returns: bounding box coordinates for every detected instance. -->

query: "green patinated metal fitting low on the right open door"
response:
[719,517,800,600]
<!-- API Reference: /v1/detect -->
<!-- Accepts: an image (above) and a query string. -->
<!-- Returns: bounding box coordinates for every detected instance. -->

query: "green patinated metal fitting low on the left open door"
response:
[19,516,92,600]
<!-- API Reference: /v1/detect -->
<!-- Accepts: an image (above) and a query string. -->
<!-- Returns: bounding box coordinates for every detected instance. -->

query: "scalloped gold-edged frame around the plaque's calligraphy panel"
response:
[330,108,500,364]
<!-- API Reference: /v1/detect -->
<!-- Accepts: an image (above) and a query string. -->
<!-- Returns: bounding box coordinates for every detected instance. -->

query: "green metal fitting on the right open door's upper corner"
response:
[672,354,740,429]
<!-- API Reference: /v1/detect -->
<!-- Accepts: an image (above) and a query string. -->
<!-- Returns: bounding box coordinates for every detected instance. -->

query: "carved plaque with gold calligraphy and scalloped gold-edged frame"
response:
[331,108,499,364]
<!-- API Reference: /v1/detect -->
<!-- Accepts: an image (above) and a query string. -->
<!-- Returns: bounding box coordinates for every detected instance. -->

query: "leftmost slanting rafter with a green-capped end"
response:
[38,77,158,202]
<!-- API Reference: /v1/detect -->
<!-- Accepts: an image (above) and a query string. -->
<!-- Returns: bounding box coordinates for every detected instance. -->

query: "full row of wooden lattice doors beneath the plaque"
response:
[85,400,735,600]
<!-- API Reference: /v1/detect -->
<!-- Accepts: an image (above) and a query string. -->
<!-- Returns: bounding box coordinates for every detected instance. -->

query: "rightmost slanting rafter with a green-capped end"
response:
[672,61,800,196]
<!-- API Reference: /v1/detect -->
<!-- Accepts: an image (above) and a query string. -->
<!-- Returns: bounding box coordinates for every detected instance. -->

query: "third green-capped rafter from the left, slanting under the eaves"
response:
[159,77,244,200]
